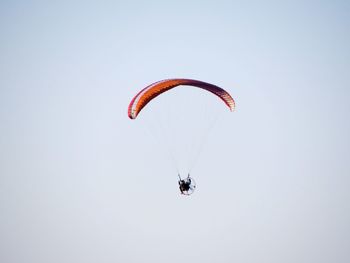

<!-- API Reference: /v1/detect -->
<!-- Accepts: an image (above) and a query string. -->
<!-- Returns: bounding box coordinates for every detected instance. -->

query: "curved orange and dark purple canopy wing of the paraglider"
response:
[128,79,235,119]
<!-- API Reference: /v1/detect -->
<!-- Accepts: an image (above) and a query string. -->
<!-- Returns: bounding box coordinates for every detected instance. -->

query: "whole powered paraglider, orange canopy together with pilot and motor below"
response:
[128,78,235,195]
